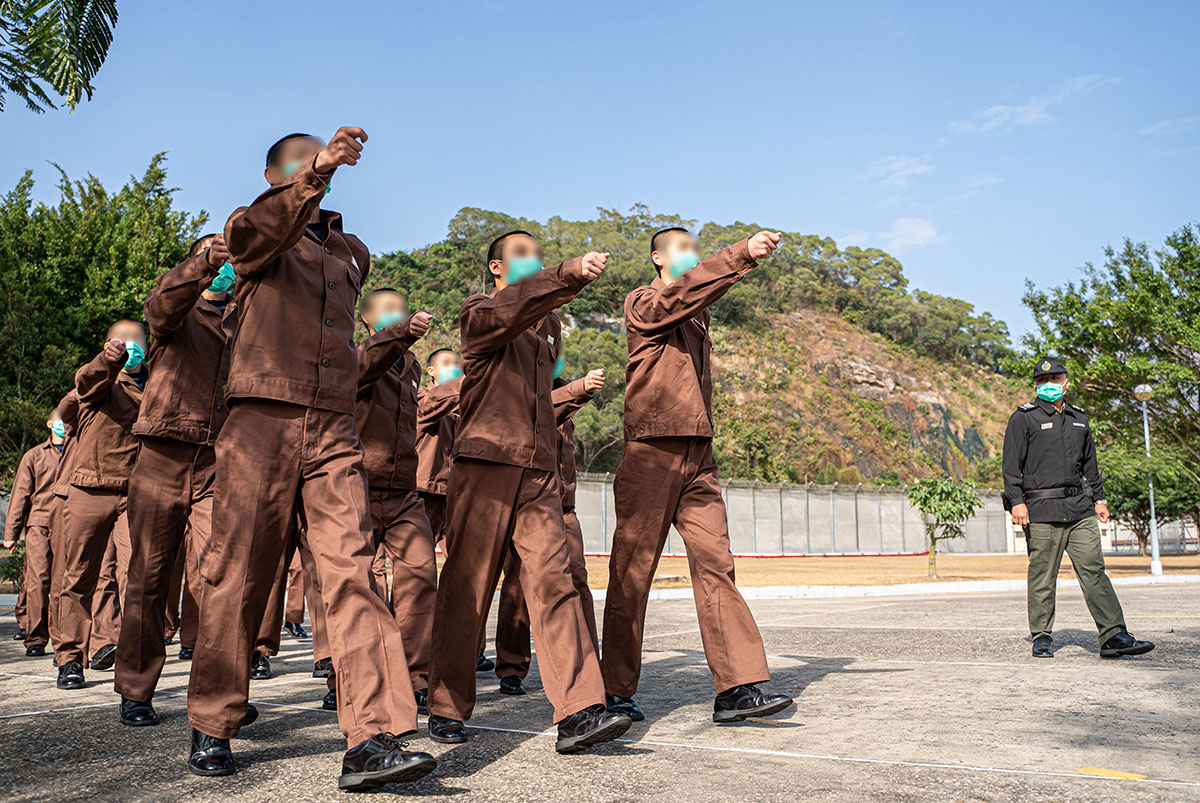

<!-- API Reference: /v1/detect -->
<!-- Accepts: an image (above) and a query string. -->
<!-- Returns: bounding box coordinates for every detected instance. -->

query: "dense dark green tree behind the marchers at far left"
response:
[0,155,206,485]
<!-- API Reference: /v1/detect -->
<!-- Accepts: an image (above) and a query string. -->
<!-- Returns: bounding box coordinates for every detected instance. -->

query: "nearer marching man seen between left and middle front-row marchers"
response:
[354,289,438,713]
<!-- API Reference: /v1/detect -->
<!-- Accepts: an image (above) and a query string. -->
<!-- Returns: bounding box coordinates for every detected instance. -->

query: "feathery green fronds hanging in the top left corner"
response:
[0,0,116,113]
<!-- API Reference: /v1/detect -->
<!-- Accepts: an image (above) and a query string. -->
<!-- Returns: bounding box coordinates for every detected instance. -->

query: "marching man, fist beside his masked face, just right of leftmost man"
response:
[50,320,145,689]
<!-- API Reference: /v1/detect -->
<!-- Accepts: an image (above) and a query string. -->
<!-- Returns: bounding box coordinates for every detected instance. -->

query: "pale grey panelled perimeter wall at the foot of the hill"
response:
[575,474,1200,556]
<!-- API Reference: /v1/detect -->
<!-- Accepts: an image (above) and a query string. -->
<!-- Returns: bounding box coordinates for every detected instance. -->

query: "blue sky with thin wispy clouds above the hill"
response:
[0,0,1200,332]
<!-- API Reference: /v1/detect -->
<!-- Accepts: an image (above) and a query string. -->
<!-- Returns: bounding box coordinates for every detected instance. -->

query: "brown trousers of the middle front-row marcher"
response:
[430,457,604,721]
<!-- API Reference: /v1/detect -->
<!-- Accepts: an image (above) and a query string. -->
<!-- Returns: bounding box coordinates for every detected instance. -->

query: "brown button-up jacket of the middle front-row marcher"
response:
[454,258,587,472]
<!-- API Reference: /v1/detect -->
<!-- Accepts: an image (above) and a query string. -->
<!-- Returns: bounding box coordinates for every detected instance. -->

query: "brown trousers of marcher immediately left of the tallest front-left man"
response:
[115,437,216,702]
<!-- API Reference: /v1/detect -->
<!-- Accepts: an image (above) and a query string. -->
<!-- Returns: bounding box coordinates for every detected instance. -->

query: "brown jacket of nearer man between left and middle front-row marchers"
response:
[354,320,421,491]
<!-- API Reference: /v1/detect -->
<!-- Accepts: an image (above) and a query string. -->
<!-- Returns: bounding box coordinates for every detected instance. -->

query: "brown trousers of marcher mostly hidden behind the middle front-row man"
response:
[496,508,600,678]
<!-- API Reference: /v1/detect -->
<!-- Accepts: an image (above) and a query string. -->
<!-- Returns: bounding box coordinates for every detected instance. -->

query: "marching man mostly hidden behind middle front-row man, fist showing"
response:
[496,368,604,695]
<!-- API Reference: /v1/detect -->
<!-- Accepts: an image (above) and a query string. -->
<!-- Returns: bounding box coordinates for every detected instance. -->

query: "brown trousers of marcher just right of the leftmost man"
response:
[50,485,130,666]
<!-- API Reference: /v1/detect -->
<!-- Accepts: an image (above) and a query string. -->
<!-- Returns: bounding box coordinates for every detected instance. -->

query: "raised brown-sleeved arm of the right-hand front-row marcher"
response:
[625,240,758,335]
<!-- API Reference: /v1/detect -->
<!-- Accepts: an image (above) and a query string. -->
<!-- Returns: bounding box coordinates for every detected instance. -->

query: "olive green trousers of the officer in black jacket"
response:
[1025,516,1126,645]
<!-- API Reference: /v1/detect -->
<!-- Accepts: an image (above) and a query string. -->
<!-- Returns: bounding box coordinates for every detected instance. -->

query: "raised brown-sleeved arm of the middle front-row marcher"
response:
[458,257,589,354]
